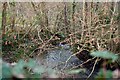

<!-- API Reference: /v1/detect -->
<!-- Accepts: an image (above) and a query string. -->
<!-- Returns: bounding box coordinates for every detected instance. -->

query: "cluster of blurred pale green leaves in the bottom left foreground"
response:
[2,59,48,78]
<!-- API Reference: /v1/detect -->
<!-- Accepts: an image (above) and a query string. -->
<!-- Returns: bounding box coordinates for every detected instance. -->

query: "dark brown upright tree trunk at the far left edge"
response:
[2,2,7,35]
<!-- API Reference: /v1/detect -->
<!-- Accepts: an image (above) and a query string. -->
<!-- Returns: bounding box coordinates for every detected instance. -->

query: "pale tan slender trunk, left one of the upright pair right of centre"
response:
[81,0,87,40]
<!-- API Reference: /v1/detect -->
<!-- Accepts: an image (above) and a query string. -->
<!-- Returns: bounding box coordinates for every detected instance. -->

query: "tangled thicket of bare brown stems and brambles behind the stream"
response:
[0,2,120,79]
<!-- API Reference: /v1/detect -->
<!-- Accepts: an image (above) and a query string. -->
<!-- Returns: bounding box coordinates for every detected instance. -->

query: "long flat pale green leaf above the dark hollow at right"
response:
[91,51,118,61]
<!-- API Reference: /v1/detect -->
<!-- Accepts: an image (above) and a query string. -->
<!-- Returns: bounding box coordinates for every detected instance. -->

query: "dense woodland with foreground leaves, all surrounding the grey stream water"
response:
[0,2,120,79]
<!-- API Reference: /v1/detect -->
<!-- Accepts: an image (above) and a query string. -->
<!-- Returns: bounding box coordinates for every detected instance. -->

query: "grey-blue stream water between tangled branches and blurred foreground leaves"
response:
[36,48,97,78]
